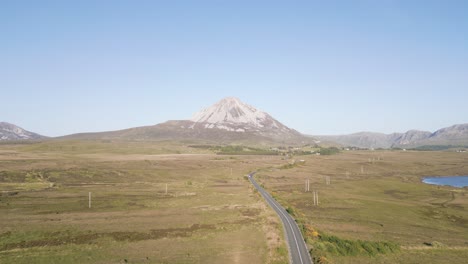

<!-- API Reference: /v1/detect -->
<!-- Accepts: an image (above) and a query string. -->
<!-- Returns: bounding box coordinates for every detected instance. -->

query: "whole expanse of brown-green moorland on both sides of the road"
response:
[0,141,468,263]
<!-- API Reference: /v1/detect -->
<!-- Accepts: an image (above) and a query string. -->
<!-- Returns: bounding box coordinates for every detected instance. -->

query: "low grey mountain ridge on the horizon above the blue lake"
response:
[316,124,468,148]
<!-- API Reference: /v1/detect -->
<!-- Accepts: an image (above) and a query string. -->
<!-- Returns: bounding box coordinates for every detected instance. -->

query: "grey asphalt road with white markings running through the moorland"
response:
[249,172,312,264]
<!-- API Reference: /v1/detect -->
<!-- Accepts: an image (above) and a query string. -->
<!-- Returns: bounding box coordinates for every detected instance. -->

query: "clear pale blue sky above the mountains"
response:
[0,0,468,136]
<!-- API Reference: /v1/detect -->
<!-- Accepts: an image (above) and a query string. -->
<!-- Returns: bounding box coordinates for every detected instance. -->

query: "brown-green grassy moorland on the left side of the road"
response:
[0,142,288,263]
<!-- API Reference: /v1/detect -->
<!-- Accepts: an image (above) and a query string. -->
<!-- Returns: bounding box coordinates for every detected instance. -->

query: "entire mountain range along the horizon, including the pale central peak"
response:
[0,97,468,148]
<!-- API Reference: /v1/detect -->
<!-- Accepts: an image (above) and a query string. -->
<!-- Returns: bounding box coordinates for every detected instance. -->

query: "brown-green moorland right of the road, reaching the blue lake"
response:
[257,151,468,263]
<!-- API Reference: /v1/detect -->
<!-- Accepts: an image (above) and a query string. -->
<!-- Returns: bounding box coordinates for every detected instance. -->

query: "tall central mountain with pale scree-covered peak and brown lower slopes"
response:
[64,97,313,143]
